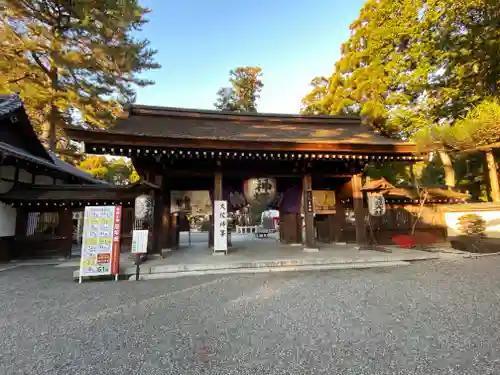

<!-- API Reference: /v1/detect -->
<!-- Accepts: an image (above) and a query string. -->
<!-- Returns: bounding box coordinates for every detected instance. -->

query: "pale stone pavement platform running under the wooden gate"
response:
[73,235,439,279]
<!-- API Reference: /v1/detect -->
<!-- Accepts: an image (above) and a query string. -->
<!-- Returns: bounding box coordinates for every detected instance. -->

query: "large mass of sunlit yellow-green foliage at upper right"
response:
[303,0,500,139]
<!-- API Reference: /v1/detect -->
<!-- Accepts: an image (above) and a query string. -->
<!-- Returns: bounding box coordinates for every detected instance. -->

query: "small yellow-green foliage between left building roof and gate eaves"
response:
[77,155,139,185]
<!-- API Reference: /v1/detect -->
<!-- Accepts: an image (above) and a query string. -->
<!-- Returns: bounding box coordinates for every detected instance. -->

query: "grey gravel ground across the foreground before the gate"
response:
[0,257,500,375]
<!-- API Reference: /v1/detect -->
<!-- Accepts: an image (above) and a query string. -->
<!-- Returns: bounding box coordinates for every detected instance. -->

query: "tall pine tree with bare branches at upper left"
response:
[0,0,159,150]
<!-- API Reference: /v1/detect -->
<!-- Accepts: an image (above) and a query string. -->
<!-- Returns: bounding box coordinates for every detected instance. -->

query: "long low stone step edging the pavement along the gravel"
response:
[129,261,410,281]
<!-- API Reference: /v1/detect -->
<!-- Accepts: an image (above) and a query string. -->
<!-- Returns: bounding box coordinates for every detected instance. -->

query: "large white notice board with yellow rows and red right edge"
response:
[80,206,122,276]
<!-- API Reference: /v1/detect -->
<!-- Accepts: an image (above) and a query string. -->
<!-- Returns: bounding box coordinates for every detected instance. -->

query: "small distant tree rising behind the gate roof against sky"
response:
[214,66,264,112]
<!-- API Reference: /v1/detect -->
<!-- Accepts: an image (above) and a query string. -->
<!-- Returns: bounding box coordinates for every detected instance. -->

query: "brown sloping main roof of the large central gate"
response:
[73,106,407,145]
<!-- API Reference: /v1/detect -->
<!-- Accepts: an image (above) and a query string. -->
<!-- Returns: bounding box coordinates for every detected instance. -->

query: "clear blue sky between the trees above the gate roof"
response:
[137,0,364,113]
